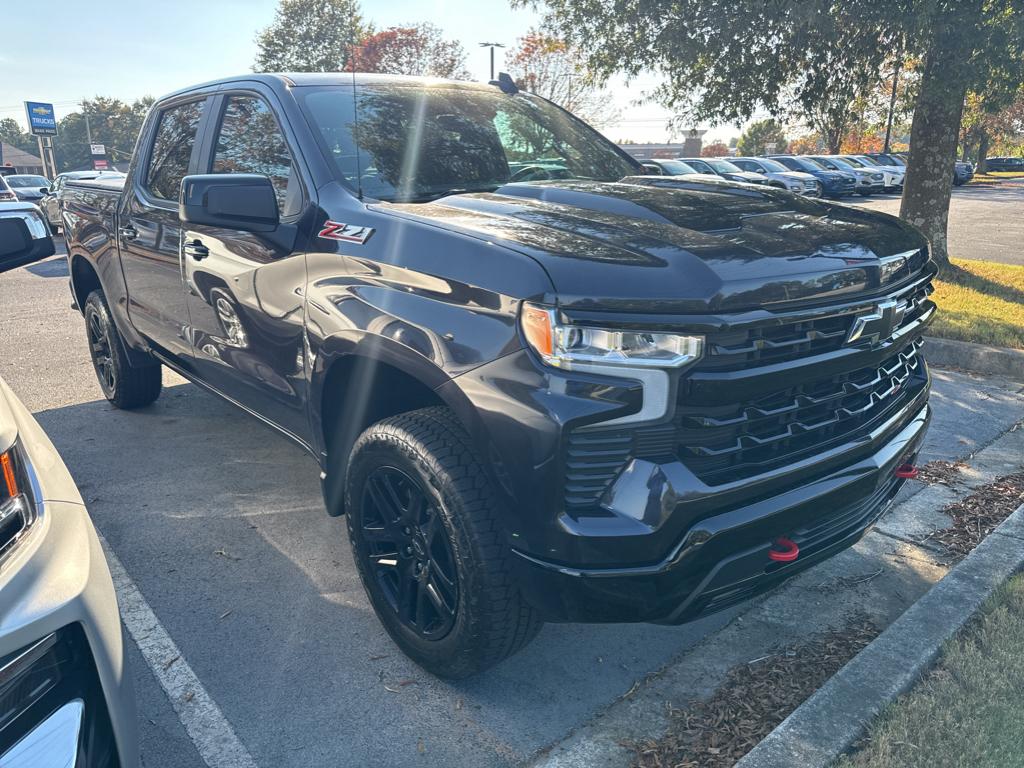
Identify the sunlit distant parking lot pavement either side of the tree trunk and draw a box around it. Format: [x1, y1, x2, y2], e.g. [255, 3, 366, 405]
[844, 181, 1024, 265]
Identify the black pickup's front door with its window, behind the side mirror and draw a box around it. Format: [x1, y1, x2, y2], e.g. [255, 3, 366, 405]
[182, 93, 310, 442]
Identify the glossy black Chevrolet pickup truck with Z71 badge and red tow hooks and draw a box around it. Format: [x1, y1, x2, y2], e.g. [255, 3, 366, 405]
[61, 74, 935, 677]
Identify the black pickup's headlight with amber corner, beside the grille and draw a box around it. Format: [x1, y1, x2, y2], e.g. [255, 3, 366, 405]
[519, 303, 703, 370]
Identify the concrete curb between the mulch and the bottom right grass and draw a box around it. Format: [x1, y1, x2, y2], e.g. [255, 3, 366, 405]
[736, 506, 1024, 768]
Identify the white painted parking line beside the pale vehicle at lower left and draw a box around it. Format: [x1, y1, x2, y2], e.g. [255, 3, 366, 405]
[99, 537, 256, 768]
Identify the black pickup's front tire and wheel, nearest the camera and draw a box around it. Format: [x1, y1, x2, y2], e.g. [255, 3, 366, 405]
[345, 408, 542, 679]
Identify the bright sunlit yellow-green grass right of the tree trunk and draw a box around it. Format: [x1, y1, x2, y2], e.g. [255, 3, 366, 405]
[929, 259, 1024, 352]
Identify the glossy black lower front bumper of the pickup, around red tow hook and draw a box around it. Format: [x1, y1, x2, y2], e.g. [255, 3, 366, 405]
[516, 406, 931, 624]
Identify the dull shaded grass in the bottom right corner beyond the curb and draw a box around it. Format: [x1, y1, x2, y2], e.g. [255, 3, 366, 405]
[836, 577, 1024, 768]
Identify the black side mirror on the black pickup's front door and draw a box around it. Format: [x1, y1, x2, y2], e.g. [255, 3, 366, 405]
[178, 173, 279, 232]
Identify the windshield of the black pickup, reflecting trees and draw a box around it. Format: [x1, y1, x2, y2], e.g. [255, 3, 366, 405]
[295, 84, 642, 202]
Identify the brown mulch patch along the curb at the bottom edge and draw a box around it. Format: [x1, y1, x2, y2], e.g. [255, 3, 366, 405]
[624, 615, 881, 768]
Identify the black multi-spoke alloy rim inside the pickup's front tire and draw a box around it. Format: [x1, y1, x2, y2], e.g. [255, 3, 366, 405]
[360, 466, 459, 640]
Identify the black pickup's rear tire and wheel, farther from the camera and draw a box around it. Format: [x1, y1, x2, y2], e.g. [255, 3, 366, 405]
[82, 290, 162, 411]
